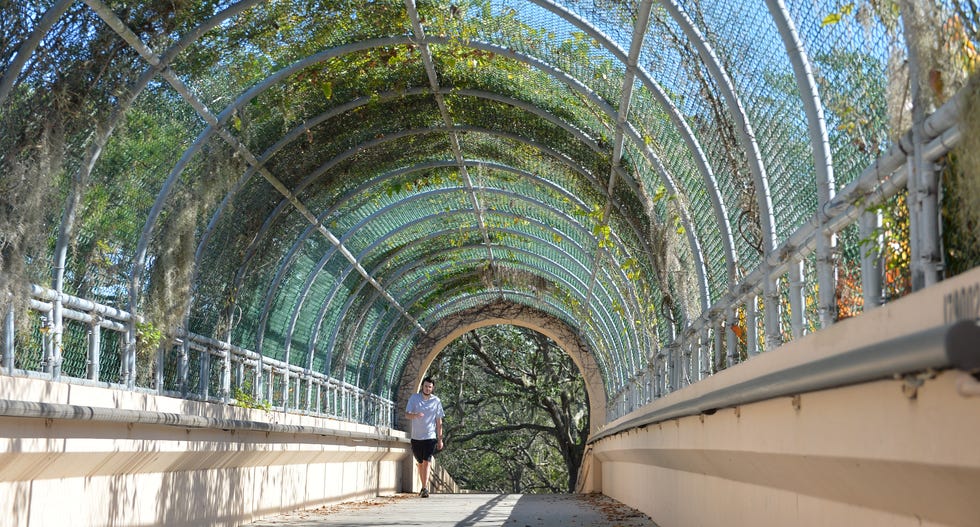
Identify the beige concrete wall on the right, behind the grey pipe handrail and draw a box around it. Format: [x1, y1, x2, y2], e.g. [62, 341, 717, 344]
[583, 272, 980, 527]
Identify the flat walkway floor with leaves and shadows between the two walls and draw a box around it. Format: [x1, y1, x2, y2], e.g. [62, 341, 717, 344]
[248, 494, 656, 527]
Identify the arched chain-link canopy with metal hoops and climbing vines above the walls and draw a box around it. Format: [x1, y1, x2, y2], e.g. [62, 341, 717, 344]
[0, 0, 980, 527]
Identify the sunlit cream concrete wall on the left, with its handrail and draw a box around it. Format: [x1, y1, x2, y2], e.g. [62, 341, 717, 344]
[0, 376, 412, 527]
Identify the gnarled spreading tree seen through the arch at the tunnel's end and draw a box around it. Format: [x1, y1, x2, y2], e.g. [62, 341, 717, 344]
[435, 326, 589, 493]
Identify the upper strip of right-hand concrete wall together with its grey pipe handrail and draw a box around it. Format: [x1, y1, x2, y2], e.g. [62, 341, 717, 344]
[590, 268, 980, 441]
